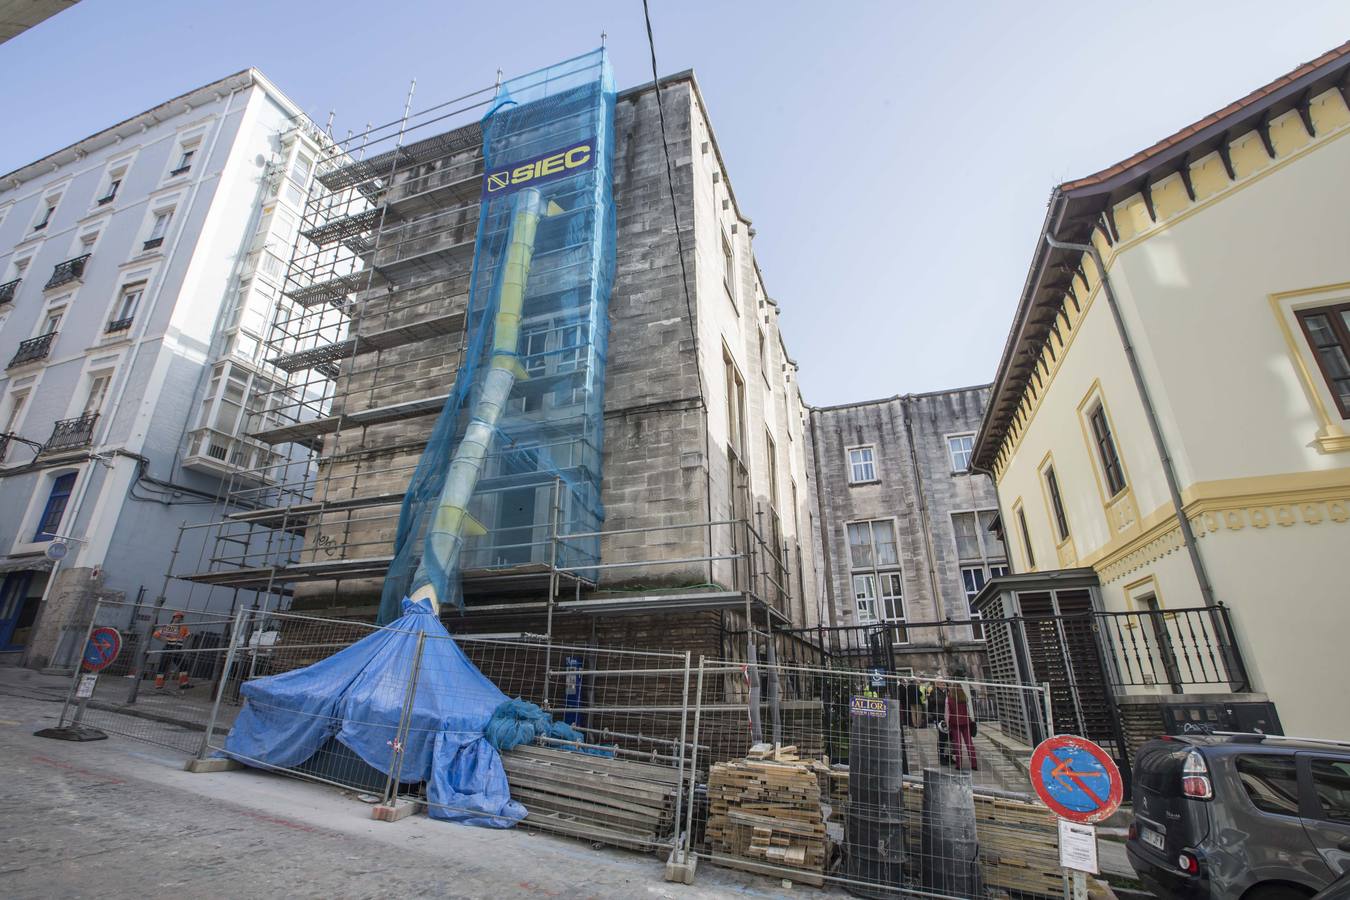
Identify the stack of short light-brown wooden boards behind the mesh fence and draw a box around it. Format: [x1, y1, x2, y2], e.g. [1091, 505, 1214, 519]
[706, 743, 829, 885]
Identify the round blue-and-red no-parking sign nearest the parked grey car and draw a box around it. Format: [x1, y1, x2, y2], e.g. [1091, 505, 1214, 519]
[1031, 734, 1125, 824]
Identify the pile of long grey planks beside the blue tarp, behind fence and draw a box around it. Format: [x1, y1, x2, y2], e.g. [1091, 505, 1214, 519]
[502, 745, 679, 851]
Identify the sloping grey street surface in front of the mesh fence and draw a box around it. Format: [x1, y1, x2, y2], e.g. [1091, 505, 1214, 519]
[0, 669, 799, 899]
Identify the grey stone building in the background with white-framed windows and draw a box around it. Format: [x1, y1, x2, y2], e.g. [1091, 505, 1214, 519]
[810, 386, 1008, 672]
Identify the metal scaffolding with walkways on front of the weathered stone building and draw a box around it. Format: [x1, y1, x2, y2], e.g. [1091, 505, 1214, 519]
[166, 52, 799, 647]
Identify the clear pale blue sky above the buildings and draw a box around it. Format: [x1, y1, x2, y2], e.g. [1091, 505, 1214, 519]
[0, 0, 1350, 405]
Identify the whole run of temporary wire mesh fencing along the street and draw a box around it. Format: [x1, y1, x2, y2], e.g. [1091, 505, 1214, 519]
[49, 603, 1096, 897]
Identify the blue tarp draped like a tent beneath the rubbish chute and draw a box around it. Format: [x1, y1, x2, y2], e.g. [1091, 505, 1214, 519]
[224, 600, 525, 827]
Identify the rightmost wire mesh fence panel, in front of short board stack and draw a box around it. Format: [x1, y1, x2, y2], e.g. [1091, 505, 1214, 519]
[680, 660, 1062, 897]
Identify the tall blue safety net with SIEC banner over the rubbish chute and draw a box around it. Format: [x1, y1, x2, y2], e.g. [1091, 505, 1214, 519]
[379, 50, 614, 623]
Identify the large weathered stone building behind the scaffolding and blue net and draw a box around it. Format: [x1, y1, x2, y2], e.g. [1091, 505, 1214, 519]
[176, 63, 819, 653]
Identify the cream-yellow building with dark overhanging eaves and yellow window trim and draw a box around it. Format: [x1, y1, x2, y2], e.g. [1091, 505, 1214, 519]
[975, 43, 1350, 743]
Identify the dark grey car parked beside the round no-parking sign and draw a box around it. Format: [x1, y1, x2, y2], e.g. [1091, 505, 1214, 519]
[1126, 734, 1350, 900]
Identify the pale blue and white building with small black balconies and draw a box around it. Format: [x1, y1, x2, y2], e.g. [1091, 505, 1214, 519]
[0, 69, 324, 667]
